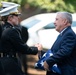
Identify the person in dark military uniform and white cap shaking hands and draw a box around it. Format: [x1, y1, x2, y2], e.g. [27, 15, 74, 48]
[0, 2, 38, 75]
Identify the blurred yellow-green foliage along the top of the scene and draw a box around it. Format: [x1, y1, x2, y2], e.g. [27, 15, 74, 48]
[1, 0, 76, 13]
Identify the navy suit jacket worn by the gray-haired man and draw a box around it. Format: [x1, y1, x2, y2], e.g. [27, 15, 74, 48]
[46, 26, 76, 75]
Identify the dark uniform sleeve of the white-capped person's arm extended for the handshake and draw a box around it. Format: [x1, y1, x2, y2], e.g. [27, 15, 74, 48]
[9, 29, 38, 54]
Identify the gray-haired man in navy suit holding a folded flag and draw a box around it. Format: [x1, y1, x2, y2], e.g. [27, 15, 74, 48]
[36, 12, 76, 75]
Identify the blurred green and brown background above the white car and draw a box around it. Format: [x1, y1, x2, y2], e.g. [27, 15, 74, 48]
[0, 0, 76, 19]
